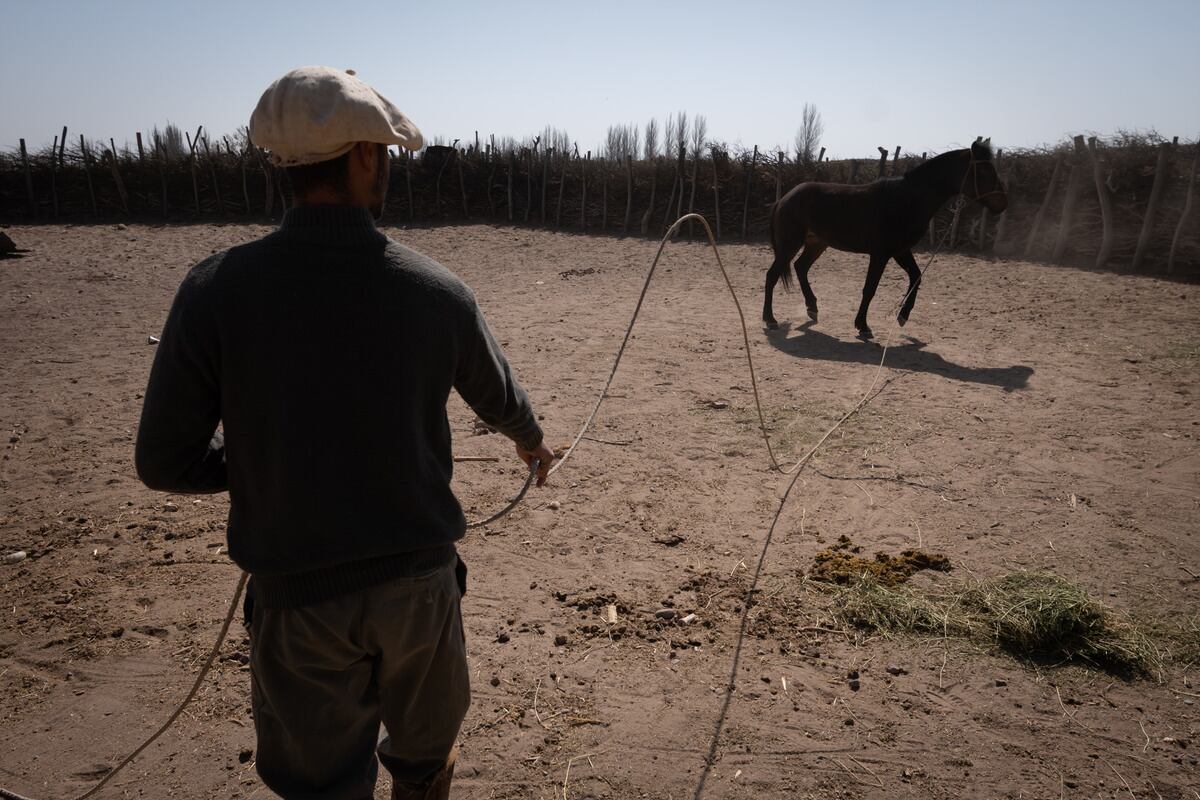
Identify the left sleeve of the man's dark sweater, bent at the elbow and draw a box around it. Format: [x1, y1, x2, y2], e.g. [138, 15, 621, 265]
[134, 261, 228, 494]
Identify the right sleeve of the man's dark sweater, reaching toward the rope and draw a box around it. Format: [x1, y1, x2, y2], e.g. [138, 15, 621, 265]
[455, 297, 542, 450]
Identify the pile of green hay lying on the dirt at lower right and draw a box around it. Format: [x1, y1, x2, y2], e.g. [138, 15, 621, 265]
[834, 572, 1163, 674]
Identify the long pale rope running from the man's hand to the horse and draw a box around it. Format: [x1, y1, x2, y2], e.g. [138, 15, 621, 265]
[0, 201, 966, 800]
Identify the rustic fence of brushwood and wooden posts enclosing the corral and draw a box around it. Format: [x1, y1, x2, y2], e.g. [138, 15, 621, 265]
[0, 126, 1200, 273]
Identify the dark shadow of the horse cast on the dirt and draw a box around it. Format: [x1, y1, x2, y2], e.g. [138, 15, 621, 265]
[766, 321, 1033, 391]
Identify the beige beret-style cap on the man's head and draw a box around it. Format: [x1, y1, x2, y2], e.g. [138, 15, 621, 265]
[250, 67, 422, 167]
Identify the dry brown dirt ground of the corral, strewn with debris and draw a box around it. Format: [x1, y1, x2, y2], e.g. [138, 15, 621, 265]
[0, 220, 1200, 800]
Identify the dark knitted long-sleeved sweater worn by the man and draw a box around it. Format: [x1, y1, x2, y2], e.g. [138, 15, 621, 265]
[137, 206, 541, 607]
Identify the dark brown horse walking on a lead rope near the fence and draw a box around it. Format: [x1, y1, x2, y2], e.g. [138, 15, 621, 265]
[762, 139, 1008, 338]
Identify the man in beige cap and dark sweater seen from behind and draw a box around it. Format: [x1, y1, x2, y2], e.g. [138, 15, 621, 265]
[137, 67, 554, 800]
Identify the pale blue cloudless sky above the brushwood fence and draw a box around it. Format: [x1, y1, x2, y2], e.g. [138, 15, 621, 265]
[0, 0, 1200, 157]
